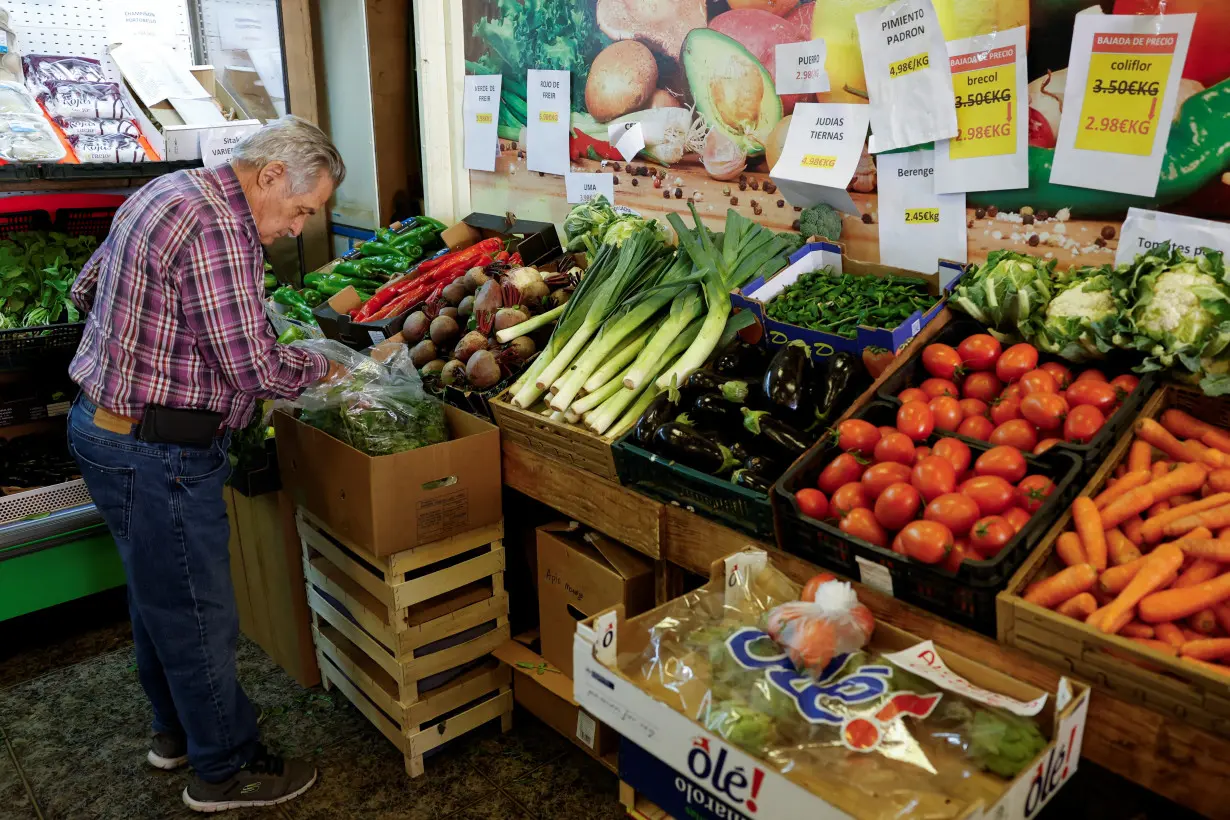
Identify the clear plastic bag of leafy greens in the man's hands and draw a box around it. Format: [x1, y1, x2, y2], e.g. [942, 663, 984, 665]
[281, 339, 449, 456]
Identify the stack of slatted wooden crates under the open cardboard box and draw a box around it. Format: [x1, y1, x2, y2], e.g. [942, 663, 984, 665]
[296, 508, 513, 777]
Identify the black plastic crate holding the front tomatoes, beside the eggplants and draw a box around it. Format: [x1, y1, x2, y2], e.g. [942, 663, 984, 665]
[774, 401, 1080, 636]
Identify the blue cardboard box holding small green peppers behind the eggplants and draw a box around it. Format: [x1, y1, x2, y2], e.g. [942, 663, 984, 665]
[734, 242, 966, 359]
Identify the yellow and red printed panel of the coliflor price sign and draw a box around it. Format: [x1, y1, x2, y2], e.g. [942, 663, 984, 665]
[1075, 33, 1178, 156]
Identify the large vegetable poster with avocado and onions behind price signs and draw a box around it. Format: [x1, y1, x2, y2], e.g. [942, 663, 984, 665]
[464, 0, 1230, 267]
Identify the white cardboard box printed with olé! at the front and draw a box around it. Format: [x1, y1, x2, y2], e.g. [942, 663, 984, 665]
[573, 551, 1090, 820]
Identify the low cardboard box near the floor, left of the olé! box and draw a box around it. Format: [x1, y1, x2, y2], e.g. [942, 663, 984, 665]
[492, 633, 619, 763]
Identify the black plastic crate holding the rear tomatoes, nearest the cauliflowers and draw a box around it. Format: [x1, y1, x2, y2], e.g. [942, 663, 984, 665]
[878, 318, 1156, 476]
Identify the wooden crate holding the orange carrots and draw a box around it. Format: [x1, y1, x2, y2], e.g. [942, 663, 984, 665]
[996, 386, 1230, 736]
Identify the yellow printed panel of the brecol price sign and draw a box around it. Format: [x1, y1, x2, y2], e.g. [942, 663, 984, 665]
[948, 45, 1020, 160]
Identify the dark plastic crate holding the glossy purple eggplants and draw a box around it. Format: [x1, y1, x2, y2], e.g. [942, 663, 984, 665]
[611, 430, 774, 541]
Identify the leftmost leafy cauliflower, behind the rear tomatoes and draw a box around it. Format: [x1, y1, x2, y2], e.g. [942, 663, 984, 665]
[950, 251, 1055, 342]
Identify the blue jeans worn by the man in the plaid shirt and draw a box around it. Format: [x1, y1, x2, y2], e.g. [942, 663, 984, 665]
[69, 396, 257, 782]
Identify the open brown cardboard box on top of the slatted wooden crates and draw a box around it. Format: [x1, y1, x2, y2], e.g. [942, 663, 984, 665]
[274, 407, 503, 556]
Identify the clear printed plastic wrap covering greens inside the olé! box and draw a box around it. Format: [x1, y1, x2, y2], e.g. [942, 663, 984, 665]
[619, 567, 1047, 820]
